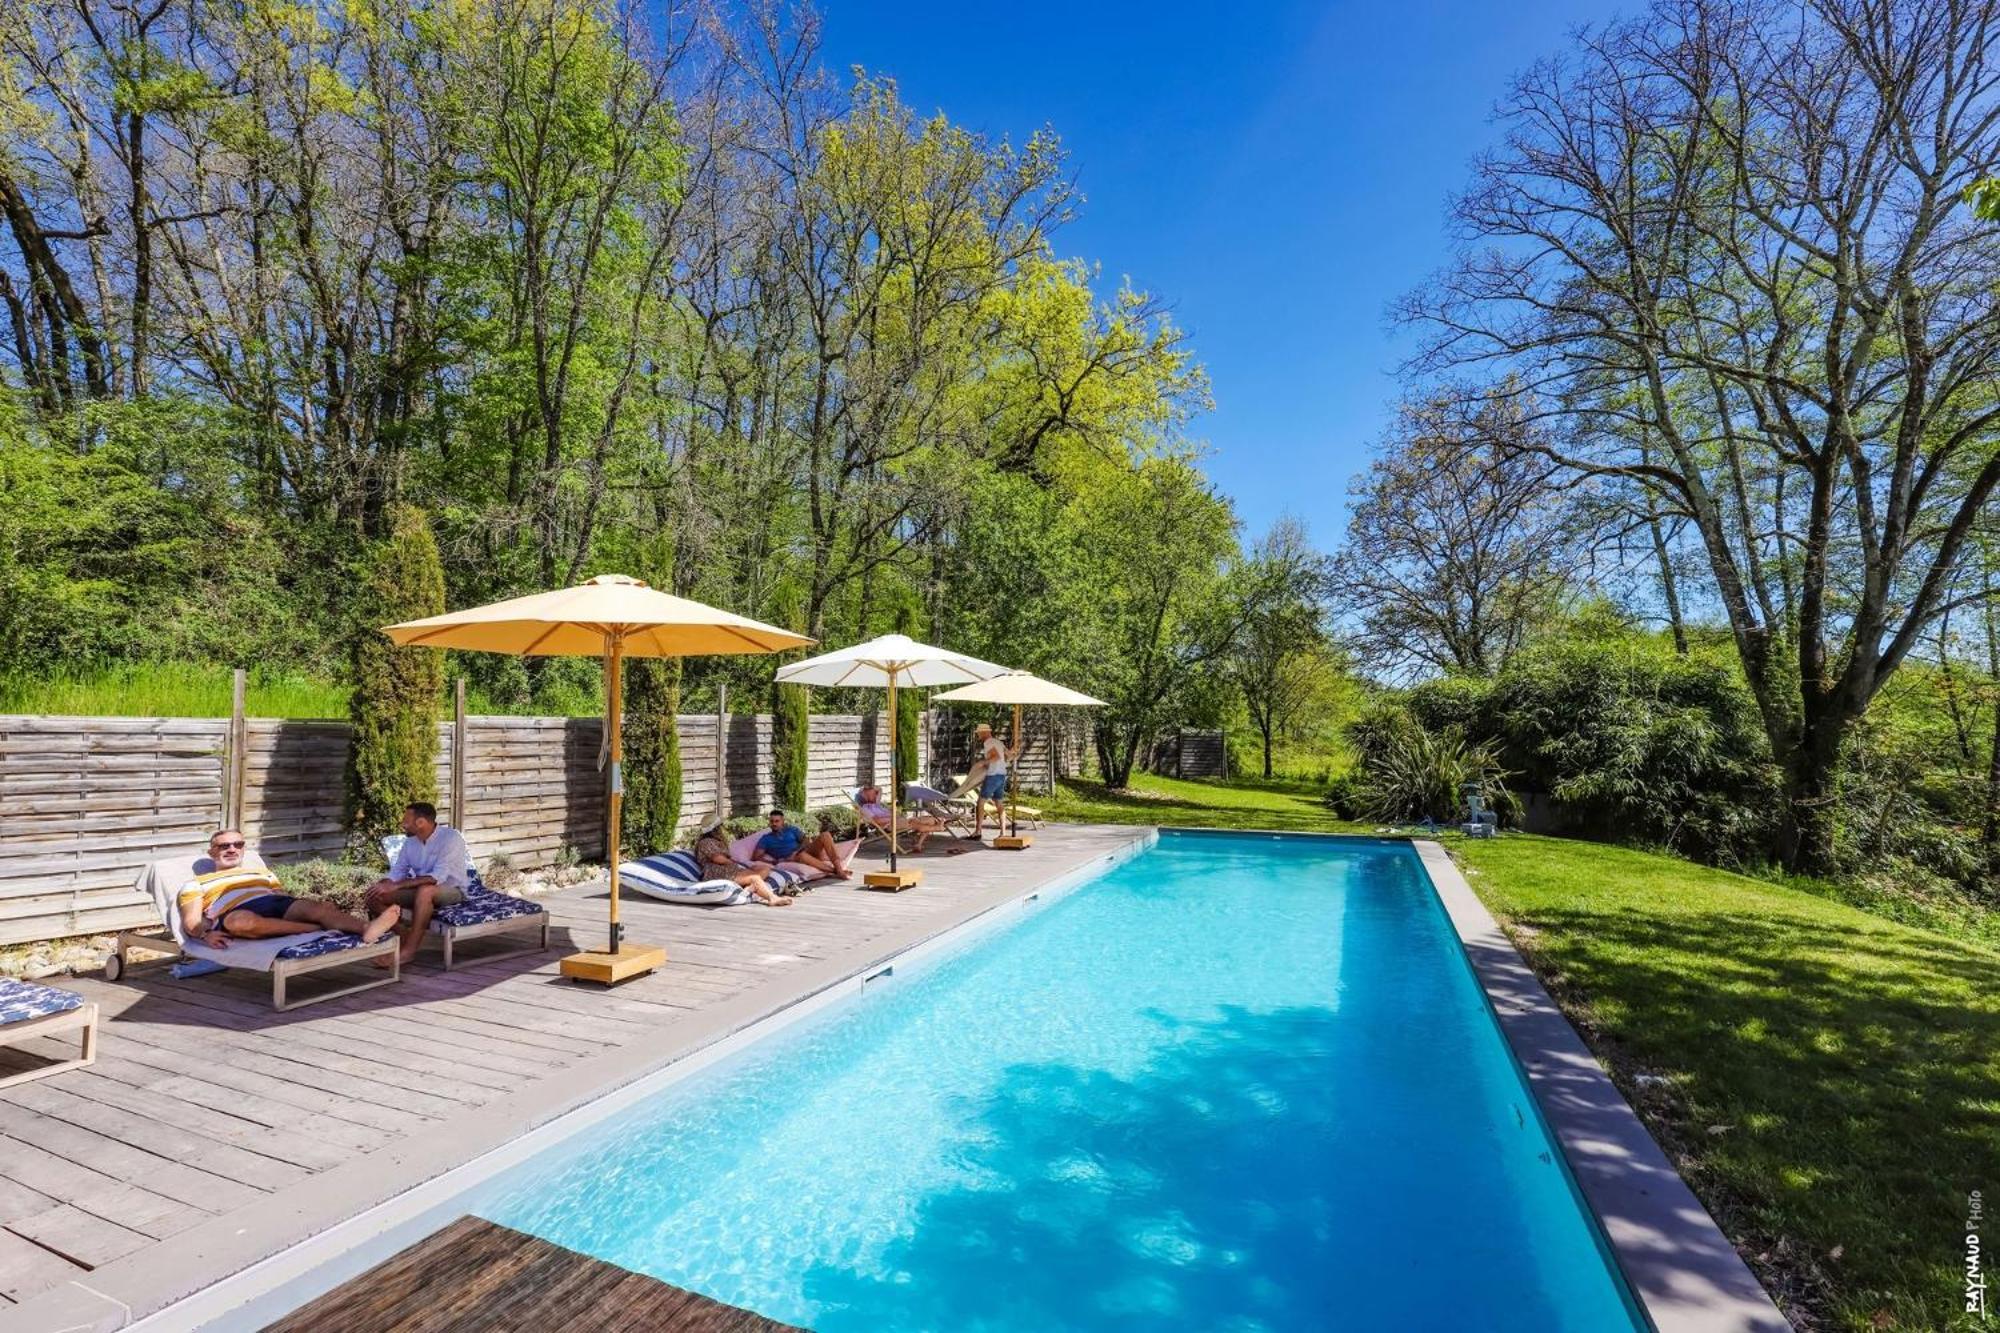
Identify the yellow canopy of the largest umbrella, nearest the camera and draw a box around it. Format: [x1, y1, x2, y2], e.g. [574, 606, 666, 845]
[382, 574, 812, 656]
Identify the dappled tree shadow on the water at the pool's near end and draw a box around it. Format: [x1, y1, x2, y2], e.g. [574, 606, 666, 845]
[788, 1009, 1616, 1333]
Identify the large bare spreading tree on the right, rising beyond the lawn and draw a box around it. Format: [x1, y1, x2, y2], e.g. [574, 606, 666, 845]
[1408, 0, 2000, 873]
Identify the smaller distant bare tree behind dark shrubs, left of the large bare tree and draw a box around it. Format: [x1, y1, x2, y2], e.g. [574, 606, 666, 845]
[1334, 390, 1582, 677]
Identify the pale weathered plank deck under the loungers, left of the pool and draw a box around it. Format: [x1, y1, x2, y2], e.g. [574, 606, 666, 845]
[0, 827, 1148, 1333]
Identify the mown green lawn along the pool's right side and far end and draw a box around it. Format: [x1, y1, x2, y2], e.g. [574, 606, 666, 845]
[1052, 777, 2000, 1333]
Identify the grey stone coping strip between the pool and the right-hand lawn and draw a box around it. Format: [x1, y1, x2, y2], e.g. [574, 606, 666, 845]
[1410, 839, 1792, 1333]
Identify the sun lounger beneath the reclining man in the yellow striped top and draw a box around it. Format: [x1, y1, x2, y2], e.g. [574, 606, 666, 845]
[104, 857, 402, 1009]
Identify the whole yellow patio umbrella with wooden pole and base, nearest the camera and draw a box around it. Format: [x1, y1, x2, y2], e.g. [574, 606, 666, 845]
[382, 574, 812, 983]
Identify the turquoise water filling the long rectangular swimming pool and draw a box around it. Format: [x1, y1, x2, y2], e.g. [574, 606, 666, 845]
[480, 835, 1640, 1333]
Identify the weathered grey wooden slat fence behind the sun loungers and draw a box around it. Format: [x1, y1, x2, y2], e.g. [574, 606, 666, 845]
[0, 715, 928, 945]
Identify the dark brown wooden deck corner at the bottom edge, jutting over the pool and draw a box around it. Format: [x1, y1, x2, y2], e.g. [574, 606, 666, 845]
[264, 1217, 798, 1333]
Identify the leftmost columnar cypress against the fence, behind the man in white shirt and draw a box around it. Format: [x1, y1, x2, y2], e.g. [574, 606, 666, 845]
[346, 504, 456, 851]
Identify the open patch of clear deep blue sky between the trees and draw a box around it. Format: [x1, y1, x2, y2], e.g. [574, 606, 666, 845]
[822, 0, 1632, 546]
